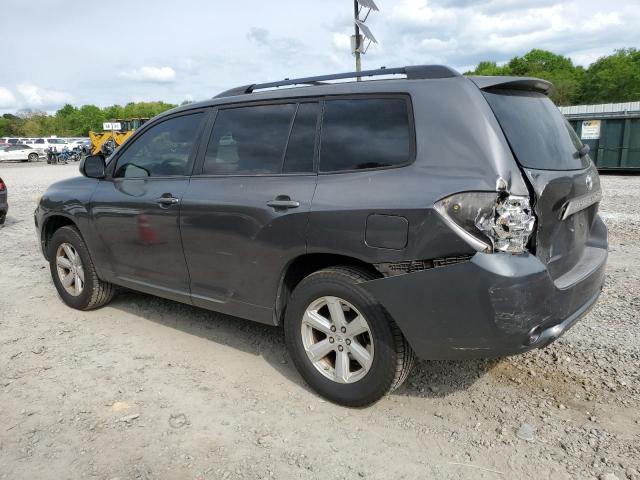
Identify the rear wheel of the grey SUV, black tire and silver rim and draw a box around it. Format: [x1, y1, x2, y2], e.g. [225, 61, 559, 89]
[284, 267, 415, 407]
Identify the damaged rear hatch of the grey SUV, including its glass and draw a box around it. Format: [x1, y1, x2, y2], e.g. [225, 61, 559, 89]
[483, 81, 602, 284]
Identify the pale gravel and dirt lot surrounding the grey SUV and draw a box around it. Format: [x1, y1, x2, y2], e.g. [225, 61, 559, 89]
[0, 164, 640, 480]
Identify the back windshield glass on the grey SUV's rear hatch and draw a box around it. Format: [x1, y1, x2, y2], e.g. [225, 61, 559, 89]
[483, 90, 589, 170]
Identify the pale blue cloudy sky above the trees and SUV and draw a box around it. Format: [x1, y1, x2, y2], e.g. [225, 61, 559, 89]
[0, 0, 640, 112]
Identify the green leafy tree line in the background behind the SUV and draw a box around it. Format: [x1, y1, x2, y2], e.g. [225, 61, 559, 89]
[0, 48, 640, 137]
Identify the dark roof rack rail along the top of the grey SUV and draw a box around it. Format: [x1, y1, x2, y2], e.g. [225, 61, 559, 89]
[213, 65, 460, 98]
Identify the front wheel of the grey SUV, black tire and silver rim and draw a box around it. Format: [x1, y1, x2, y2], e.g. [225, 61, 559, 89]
[47, 226, 115, 310]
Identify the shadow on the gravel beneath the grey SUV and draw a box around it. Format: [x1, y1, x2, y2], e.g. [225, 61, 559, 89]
[109, 290, 500, 398]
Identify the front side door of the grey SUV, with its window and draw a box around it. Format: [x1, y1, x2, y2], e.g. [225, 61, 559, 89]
[91, 111, 205, 301]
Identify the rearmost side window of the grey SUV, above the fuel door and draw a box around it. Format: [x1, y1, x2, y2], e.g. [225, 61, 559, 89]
[320, 98, 411, 172]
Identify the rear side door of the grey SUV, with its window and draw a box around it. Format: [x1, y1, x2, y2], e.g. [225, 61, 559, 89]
[181, 101, 320, 323]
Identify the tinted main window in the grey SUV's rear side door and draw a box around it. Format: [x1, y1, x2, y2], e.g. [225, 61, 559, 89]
[202, 103, 296, 175]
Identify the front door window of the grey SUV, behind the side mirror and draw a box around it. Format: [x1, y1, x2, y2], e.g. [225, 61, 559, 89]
[113, 113, 202, 178]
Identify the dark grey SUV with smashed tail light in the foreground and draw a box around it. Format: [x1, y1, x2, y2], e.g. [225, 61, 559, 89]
[35, 66, 607, 406]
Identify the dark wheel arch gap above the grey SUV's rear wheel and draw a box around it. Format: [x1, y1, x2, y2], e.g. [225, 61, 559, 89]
[274, 253, 382, 325]
